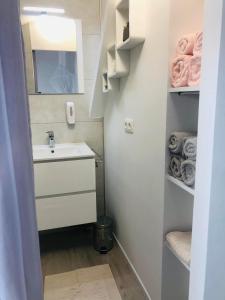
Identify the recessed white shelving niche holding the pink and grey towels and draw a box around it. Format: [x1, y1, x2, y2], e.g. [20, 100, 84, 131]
[162, 0, 204, 300]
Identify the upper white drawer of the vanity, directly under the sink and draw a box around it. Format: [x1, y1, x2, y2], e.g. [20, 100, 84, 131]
[34, 159, 96, 197]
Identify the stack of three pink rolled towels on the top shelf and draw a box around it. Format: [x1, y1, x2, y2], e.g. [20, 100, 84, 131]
[171, 32, 203, 87]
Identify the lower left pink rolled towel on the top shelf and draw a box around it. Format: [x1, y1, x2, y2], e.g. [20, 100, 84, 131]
[171, 55, 192, 87]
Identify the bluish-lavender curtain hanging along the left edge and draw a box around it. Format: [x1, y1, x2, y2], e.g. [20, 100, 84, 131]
[0, 0, 43, 300]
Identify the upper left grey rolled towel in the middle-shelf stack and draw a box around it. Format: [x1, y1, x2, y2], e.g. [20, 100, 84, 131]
[168, 131, 194, 154]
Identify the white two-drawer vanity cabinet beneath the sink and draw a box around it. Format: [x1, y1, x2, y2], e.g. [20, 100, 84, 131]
[34, 143, 97, 231]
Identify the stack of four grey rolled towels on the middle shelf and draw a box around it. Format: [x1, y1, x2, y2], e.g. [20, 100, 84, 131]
[168, 131, 197, 187]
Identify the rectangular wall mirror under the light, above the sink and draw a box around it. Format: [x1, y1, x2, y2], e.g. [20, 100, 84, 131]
[21, 15, 84, 95]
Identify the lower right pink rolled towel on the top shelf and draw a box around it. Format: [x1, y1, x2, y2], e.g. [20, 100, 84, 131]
[188, 55, 201, 86]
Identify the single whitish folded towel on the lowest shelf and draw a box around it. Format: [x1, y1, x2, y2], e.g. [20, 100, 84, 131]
[166, 231, 192, 266]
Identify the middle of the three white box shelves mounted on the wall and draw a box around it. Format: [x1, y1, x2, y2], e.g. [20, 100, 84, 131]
[107, 44, 130, 79]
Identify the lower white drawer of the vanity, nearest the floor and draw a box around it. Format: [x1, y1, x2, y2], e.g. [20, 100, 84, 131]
[36, 192, 97, 231]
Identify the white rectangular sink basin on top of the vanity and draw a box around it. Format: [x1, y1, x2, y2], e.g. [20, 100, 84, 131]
[33, 143, 95, 162]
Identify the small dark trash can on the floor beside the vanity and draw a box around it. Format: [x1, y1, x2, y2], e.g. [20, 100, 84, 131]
[94, 216, 113, 254]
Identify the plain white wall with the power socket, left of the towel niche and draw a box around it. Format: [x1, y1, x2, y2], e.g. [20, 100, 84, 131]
[104, 0, 168, 300]
